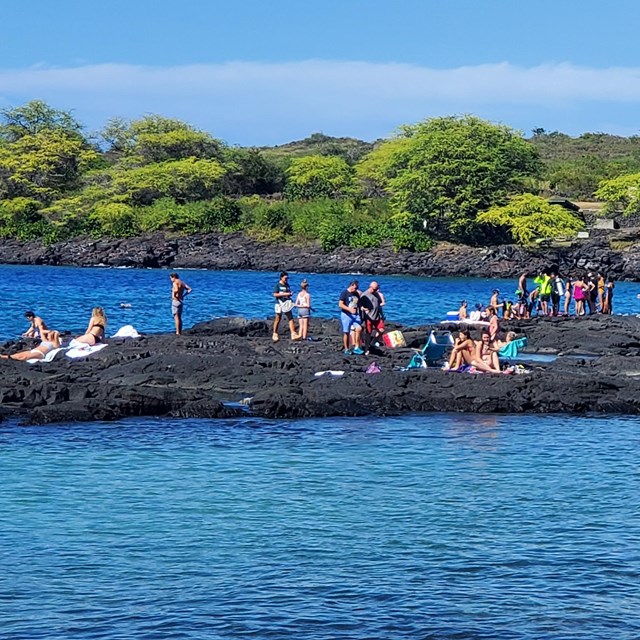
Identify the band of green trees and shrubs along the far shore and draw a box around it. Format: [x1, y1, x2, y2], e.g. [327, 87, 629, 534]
[0, 101, 640, 251]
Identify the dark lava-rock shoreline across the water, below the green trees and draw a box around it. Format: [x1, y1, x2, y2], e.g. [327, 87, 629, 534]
[0, 230, 640, 280]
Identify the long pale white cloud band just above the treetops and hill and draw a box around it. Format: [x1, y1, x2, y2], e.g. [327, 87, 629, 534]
[0, 60, 640, 144]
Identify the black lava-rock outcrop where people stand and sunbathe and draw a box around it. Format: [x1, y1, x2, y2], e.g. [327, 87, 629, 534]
[0, 316, 640, 424]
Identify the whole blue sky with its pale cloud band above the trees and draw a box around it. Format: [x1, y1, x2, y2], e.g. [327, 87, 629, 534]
[0, 0, 640, 146]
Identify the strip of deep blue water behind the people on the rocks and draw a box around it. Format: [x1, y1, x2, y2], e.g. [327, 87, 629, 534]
[0, 265, 640, 340]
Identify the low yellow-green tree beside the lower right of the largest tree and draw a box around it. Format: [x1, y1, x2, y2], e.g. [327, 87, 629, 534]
[478, 193, 584, 245]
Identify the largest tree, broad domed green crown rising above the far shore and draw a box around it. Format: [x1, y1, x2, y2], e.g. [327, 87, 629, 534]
[360, 116, 540, 240]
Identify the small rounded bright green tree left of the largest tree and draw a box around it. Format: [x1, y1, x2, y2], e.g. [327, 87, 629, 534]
[285, 156, 356, 200]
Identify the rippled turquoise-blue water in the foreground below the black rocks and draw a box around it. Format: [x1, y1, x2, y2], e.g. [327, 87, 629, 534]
[0, 415, 640, 640]
